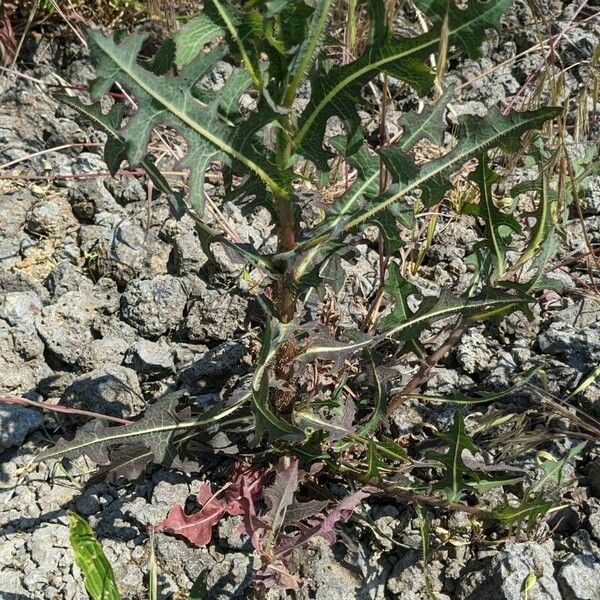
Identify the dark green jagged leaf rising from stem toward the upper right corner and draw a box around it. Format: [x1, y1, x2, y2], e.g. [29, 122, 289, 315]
[293, 0, 511, 171]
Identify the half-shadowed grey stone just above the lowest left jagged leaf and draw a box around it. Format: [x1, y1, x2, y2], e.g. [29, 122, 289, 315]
[62, 365, 146, 418]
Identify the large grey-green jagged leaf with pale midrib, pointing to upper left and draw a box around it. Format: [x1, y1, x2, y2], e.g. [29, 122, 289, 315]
[88, 31, 288, 215]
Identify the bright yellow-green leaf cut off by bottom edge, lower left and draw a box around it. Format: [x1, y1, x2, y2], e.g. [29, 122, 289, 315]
[69, 512, 121, 600]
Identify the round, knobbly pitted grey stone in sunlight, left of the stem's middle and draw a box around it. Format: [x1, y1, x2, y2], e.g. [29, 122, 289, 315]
[121, 275, 188, 338]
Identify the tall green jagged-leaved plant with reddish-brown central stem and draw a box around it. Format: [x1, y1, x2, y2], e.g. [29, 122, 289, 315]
[39, 0, 561, 502]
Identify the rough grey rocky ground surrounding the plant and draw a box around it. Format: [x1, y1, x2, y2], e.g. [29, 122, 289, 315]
[0, 0, 600, 600]
